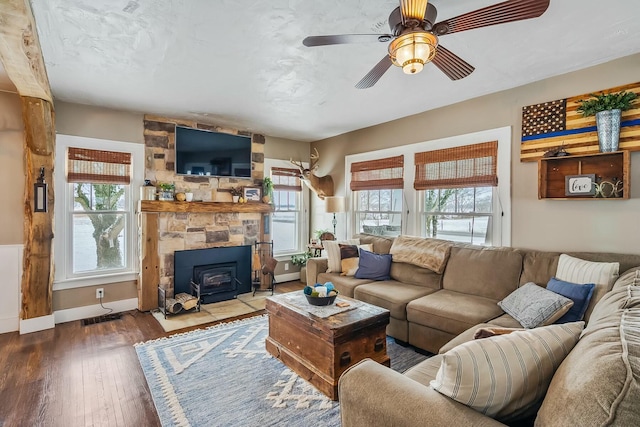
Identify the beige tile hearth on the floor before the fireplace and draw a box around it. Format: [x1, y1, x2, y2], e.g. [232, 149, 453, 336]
[151, 292, 271, 332]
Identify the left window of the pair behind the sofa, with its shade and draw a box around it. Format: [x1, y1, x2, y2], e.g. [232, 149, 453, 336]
[349, 156, 404, 236]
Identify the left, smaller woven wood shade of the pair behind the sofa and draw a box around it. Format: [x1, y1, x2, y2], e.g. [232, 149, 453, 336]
[349, 156, 404, 191]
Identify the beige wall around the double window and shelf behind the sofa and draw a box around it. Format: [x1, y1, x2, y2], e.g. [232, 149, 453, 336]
[311, 54, 640, 254]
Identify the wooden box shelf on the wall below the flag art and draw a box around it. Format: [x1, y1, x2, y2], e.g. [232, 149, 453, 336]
[538, 150, 631, 200]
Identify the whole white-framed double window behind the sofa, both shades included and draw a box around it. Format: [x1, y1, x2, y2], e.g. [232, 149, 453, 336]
[345, 127, 511, 246]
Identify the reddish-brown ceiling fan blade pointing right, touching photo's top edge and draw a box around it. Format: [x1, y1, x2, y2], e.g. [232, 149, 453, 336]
[433, 0, 550, 36]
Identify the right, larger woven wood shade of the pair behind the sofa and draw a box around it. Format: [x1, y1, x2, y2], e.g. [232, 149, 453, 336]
[413, 141, 498, 190]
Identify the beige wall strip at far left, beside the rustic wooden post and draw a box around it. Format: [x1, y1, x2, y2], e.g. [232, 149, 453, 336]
[0, 92, 25, 245]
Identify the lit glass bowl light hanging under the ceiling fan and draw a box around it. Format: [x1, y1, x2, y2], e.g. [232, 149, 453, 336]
[389, 31, 438, 74]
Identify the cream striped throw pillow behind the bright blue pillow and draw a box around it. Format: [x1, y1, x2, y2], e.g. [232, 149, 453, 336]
[555, 254, 620, 319]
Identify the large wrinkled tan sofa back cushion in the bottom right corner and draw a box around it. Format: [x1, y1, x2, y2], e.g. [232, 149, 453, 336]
[536, 286, 640, 426]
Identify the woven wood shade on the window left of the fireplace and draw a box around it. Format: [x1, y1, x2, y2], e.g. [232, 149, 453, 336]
[67, 147, 131, 184]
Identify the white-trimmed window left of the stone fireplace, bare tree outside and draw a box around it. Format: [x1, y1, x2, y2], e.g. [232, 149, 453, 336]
[54, 135, 144, 289]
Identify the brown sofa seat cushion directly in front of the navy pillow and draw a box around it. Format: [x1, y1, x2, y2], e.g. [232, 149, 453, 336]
[354, 280, 435, 320]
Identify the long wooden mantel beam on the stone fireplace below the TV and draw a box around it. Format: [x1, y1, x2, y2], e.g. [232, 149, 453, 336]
[138, 200, 273, 213]
